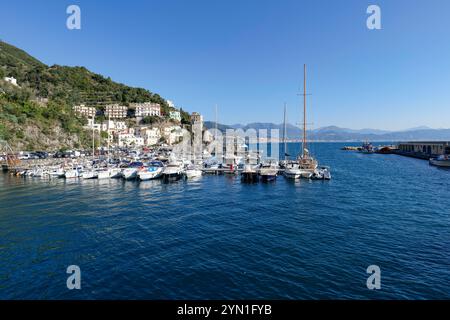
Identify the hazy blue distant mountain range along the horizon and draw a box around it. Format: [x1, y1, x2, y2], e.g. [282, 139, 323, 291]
[205, 121, 450, 141]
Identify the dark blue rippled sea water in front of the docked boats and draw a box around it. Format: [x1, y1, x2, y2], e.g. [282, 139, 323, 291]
[0, 143, 450, 299]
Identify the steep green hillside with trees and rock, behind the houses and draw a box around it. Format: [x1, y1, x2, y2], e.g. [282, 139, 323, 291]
[0, 41, 189, 150]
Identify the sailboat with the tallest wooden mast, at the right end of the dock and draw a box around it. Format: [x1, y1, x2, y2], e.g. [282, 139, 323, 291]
[284, 64, 331, 179]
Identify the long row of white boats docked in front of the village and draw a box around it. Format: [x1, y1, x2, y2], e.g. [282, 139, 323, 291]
[11, 158, 331, 182]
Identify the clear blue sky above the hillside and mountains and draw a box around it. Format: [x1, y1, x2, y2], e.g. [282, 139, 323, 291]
[0, 0, 450, 130]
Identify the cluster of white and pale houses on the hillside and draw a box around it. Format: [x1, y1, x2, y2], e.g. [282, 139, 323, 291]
[73, 101, 203, 147]
